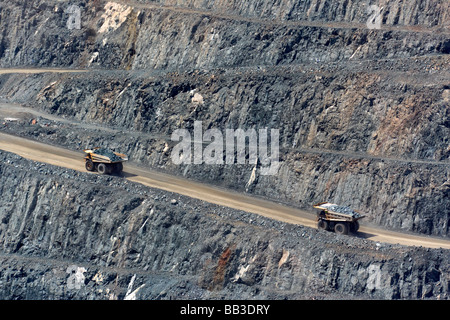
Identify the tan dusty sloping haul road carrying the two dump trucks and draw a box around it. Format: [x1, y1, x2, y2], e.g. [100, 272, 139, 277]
[0, 133, 450, 249]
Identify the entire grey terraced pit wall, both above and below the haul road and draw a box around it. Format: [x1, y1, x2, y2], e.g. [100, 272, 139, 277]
[0, 0, 450, 299]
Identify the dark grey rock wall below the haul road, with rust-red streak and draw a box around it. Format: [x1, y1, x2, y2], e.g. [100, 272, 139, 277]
[0, 152, 450, 299]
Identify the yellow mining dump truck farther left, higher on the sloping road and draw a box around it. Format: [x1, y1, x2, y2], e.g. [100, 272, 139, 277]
[84, 148, 128, 174]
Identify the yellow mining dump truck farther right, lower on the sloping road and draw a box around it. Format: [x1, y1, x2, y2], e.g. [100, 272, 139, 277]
[313, 202, 364, 234]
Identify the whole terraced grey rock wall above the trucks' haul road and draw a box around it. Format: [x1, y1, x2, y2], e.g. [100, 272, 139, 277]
[0, 1, 450, 236]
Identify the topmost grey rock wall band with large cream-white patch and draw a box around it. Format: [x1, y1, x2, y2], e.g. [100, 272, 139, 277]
[0, 0, 450, 70]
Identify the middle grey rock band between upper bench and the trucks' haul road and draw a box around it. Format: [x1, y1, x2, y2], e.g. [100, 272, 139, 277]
[0, 57, 450, 236]
